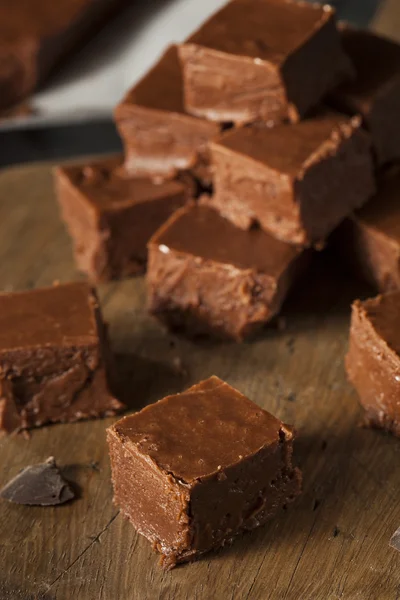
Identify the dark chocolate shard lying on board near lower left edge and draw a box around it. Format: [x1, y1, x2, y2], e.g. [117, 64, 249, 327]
[0, 456, 75, 506]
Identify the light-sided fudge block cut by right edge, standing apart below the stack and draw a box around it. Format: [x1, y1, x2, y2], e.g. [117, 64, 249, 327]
[346, 291, 400, 436]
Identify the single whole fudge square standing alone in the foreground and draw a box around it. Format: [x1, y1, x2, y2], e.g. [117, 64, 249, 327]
[107, 376, 301, 568]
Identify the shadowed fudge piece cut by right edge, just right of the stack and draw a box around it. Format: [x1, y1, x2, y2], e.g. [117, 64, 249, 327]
[333, 171, 400, 292]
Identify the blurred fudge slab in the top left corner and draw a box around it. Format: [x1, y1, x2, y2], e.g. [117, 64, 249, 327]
[0, 0, 128, 109]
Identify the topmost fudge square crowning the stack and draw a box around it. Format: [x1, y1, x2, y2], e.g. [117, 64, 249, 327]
[179, 0, 353, 124]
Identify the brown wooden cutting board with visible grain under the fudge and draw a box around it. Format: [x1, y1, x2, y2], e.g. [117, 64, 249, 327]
[0, 161, 400, 600]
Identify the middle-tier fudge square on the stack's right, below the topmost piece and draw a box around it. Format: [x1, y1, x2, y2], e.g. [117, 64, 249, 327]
[210, 114, 375, 246]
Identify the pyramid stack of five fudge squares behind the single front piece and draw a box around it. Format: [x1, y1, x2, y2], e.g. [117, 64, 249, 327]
[57, 0, 384, 340]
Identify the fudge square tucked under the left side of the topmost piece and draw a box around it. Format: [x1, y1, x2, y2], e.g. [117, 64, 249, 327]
[115, 46, 220, 183]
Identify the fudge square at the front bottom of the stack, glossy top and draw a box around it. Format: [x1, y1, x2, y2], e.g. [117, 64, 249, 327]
[147, 205, 308, 341]
